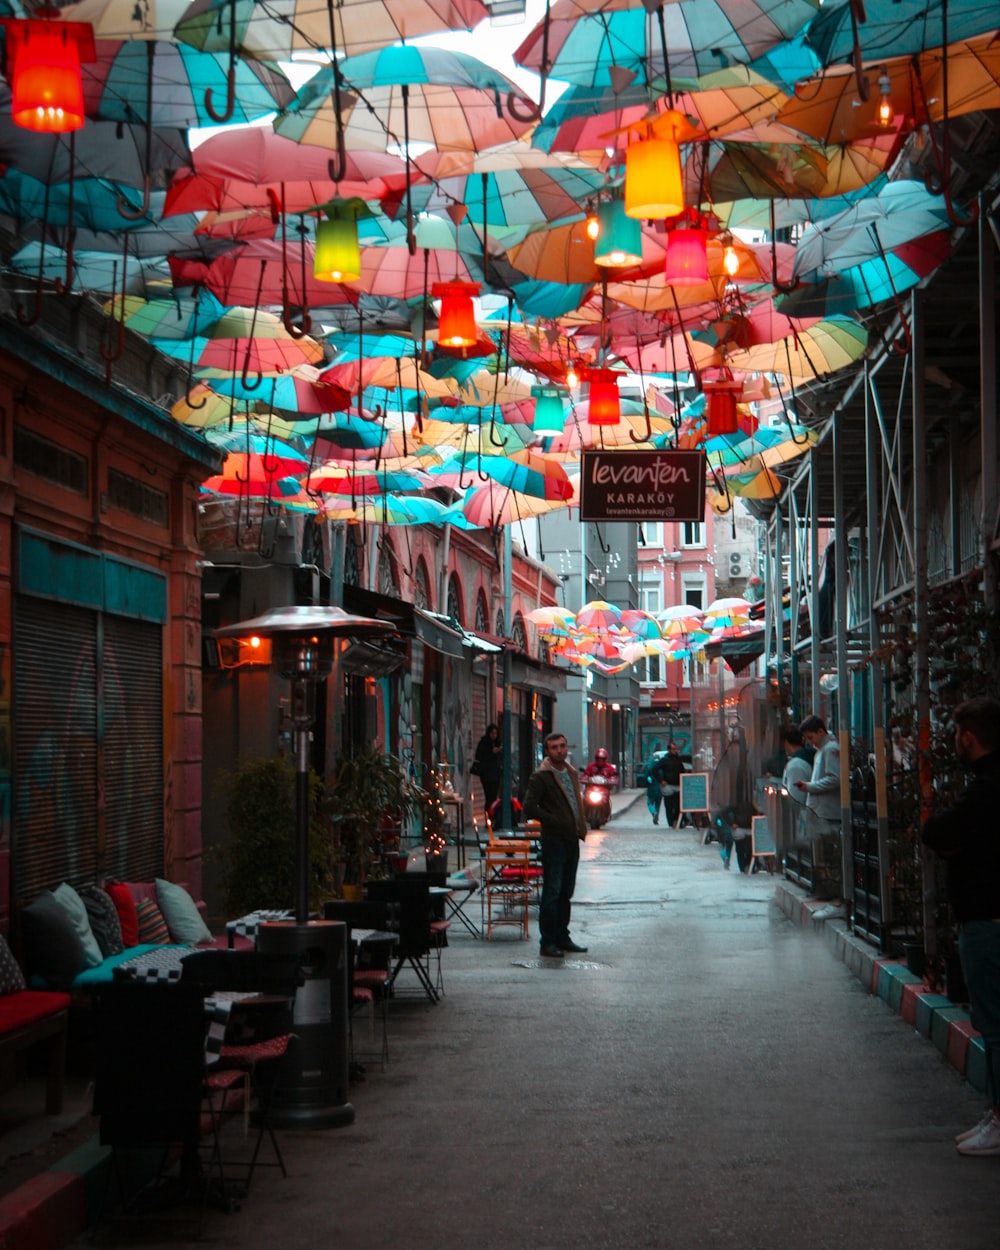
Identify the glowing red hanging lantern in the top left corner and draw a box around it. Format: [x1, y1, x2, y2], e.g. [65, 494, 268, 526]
[3, 16, 98, 134]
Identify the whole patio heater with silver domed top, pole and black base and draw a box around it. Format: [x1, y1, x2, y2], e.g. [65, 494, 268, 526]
[215, 606, 394, 1129]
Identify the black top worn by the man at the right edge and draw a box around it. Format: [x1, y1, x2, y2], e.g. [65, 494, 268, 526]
[920, 751, 1000, 924]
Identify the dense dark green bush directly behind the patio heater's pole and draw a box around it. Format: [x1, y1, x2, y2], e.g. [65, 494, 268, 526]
[211, 759, 334, 916]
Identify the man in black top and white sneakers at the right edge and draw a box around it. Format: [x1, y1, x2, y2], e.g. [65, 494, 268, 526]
[921, 696, 1000, 1155]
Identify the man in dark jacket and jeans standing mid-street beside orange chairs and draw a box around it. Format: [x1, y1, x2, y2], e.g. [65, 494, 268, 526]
[524, 734, 586, 959]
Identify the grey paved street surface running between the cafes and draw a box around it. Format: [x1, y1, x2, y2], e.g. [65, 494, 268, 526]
[78, 803, 1000, 1250]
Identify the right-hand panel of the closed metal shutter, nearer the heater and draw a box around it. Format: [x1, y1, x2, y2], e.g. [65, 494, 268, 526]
[101, 615, 164, 881]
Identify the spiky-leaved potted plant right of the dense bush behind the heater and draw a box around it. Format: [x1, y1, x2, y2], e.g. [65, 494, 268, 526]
[323, 746, 419, 893]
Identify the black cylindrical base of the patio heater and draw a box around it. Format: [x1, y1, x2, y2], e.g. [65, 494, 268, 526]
[258, 920, 354, 1129]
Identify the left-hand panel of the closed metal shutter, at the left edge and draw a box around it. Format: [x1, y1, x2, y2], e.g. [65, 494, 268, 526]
[11, 596, 98, 901]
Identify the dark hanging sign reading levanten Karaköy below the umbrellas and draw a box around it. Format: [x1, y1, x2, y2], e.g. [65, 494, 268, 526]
[580, 448, 705, 521]
